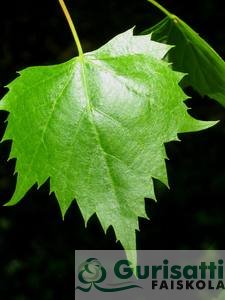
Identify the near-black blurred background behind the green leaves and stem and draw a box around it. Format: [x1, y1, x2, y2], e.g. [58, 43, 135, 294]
[0, 0, 225, 300]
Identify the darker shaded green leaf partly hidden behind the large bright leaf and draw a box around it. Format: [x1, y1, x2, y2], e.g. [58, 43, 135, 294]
[143, 15, 225, 106]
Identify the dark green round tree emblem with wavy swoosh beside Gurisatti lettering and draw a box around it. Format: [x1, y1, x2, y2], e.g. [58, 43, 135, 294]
[75, 258, 141, 293]
